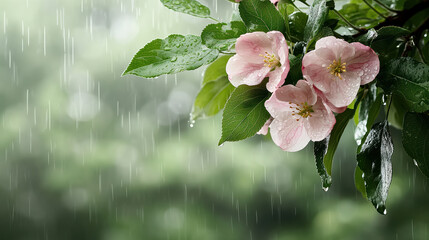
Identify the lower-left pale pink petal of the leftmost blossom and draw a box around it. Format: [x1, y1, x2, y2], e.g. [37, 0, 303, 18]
[226, 55, 270, 87]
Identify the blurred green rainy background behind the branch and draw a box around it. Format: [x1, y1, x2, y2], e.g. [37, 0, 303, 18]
[0, 0, 429, 240]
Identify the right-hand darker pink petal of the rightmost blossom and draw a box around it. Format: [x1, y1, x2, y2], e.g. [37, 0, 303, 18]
[347, 42, 380, 85]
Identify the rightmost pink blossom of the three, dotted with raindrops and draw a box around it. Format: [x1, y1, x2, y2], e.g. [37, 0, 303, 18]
[302, 37, 380, 112]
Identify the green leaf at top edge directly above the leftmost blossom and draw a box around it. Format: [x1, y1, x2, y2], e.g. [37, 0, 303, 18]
[239, 0, 285, 32]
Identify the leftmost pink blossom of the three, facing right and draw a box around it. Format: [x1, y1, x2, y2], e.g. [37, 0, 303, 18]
[226, 31, 289, 92]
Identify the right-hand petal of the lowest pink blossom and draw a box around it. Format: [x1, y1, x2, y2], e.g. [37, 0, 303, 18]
[304, 97, 336, 141]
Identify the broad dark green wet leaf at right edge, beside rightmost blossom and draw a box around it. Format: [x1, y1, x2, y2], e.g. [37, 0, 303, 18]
[377, 58, 429, 112]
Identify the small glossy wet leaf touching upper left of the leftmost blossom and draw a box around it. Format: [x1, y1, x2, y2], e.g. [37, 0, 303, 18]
[201, 21, 247, 51]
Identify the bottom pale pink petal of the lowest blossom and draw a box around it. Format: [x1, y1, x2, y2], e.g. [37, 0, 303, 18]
[270, 116, 310, 152]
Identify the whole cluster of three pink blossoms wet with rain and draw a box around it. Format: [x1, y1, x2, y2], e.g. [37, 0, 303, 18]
[226, 31, 380, 152]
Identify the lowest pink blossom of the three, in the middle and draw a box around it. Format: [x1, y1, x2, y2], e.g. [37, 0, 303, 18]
[265, 80, 336, 152]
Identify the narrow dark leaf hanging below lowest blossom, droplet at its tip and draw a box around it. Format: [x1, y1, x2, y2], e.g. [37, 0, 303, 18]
[314, 137, 332, 191]
